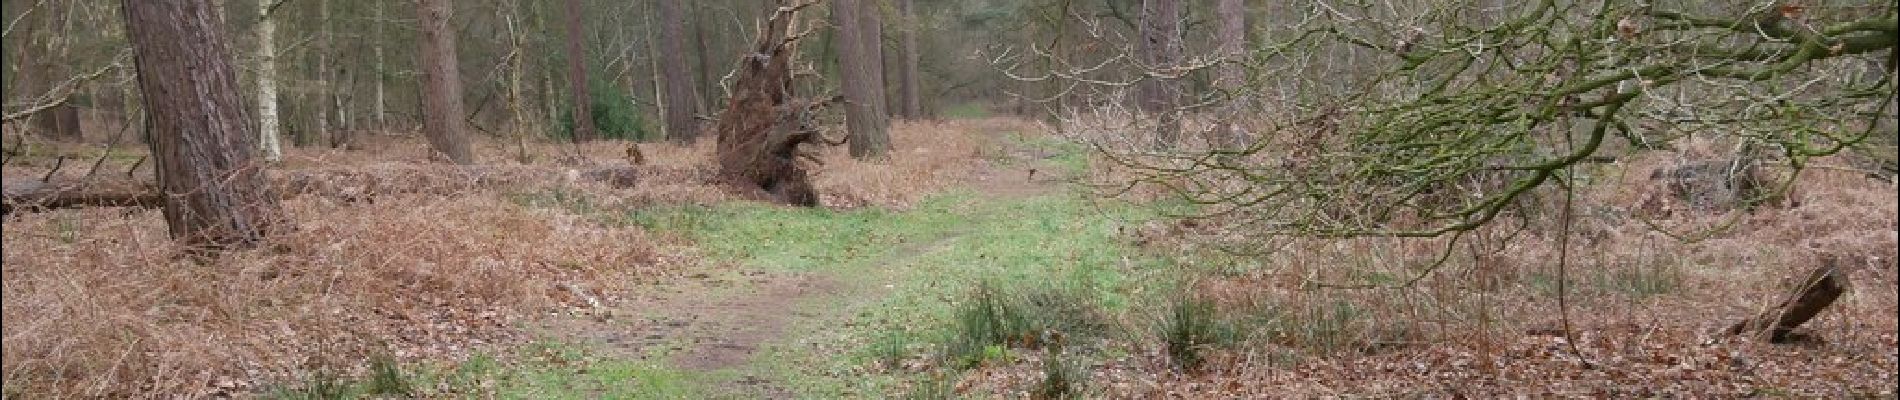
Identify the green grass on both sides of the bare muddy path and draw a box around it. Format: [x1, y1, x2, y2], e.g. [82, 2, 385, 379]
[475, 135, 1170, 398]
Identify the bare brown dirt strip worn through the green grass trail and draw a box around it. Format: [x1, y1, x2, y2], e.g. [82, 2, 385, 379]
[547, 139, 1062, 398]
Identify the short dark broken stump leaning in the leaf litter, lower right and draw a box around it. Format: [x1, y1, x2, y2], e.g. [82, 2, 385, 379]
[1727, 258, 1849, 343]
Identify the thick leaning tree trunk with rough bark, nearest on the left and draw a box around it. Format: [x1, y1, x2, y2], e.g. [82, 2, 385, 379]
[122, 0, 285, 248]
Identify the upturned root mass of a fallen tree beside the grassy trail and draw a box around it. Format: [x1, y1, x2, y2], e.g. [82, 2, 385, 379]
[714, 0, 840, 207]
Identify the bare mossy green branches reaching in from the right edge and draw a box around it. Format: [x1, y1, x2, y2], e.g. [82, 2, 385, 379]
[1018, 0, 1900, 245]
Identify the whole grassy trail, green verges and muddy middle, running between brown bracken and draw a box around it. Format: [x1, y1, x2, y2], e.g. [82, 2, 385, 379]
[446, 132, 1151, 398]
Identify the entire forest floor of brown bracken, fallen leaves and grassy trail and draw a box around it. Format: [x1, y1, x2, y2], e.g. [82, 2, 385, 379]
[0, 114, 1900, 398]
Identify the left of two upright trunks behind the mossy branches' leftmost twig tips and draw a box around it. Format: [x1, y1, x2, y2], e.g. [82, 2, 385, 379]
[1136, 0, 1182, 148]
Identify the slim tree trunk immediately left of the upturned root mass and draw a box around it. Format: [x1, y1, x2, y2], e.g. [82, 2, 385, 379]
[656, 2, 699, 142]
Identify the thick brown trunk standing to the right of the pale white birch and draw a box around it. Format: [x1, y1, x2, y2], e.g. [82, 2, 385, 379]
[416, 0, 475, 165]
